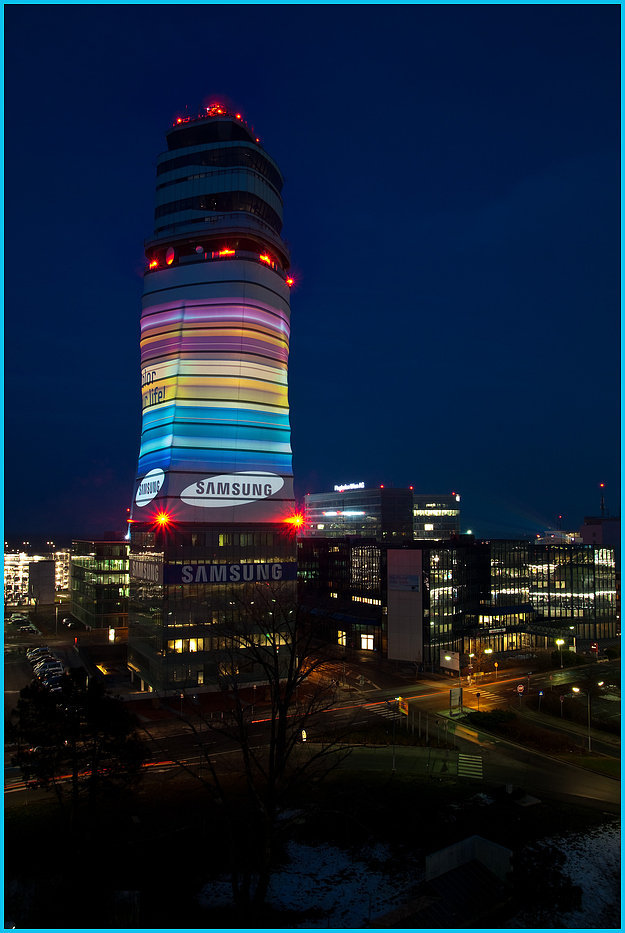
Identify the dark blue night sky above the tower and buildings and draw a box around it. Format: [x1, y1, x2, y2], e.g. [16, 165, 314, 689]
[5, 5, 620, 543]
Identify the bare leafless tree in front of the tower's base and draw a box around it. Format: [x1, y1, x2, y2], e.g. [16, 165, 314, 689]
[144, 583, 349, 909]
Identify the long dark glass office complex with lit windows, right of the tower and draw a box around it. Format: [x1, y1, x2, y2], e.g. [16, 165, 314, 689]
[298, 535, 619, 665]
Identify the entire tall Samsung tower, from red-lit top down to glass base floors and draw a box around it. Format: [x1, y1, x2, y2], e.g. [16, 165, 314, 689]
[129, 104, 297, 689]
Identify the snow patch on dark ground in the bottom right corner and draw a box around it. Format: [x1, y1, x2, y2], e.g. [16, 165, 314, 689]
[510, 823, 621, 930]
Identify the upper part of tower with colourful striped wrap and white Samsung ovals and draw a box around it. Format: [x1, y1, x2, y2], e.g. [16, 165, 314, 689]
[131, 104, 294, 527]
